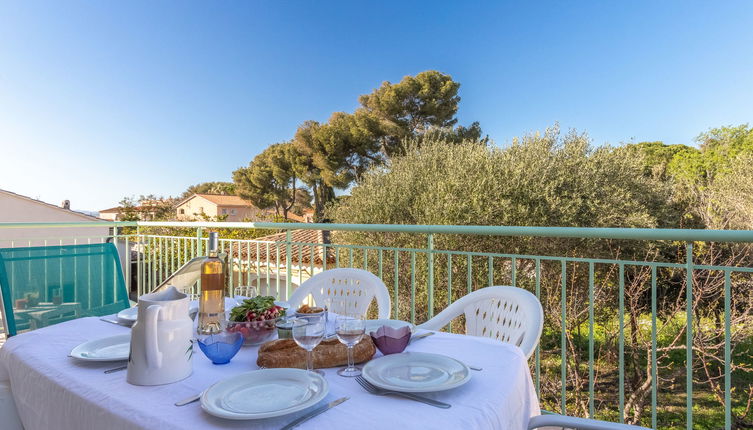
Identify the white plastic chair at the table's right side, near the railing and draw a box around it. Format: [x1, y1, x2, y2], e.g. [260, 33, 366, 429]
[419, 287, 544, 358]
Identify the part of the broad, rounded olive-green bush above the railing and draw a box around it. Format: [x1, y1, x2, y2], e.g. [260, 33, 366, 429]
[333, 128, 670, 233]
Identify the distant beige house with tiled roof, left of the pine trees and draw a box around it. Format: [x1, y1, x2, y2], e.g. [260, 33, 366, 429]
[175, 194, 274, 221]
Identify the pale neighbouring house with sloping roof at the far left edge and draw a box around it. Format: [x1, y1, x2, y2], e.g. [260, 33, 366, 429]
[0, 190, 110, 248]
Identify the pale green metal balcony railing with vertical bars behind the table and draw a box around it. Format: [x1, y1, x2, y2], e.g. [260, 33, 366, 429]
[0, 222, 753, 429]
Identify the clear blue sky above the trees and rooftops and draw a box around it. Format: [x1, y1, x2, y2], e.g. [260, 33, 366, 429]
[0, 0, 753, 210]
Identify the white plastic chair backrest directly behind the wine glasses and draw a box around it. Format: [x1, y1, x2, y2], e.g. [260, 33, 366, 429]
[288, 269, 390, 319]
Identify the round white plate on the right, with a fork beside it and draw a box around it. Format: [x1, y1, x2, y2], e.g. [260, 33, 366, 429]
[361, 352, 471, 393]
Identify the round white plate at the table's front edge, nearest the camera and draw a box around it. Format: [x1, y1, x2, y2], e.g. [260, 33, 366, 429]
[201, 369, 329, 420]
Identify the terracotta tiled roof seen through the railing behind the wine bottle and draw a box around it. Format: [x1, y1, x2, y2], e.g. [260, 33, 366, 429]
[227, 230, 335, 266]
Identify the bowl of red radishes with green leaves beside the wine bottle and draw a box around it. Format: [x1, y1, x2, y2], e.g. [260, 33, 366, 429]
[226, 296, 285, 346]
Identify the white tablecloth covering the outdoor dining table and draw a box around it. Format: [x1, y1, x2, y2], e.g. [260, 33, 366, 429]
[0, 318, 539, 430]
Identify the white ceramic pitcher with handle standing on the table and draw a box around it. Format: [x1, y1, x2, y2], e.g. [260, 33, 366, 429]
[126, 287, 193, 385]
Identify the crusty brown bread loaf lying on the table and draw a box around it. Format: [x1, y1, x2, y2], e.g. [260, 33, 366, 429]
[256, 336, 376, 369]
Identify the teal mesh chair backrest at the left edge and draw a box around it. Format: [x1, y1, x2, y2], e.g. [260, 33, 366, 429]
[0, 243, 129, 336]
